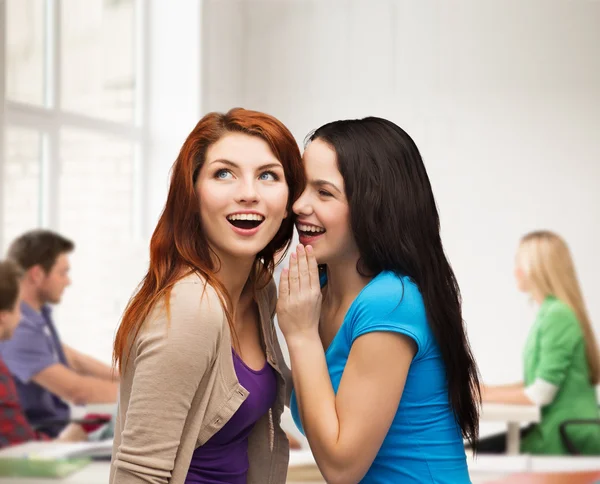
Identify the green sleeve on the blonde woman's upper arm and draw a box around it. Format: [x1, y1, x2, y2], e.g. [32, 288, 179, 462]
[535, 305, 583, 387]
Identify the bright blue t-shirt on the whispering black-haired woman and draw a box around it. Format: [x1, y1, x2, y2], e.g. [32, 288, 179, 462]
[290, 272, 471, 484]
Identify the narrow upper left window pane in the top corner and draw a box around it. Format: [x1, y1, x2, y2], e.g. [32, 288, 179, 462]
[6, 0, 45, 104]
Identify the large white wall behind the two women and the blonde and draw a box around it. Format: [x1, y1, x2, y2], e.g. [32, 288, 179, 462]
[203, 0, 600, 383]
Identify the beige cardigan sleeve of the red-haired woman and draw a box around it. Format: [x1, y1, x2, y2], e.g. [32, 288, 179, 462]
[112, 282, 226, 484]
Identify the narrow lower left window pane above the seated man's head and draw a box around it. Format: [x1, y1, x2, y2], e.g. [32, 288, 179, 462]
[2, 128, 41, 249]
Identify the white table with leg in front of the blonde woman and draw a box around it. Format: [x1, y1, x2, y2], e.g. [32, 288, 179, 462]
[480, 402, 541, 455]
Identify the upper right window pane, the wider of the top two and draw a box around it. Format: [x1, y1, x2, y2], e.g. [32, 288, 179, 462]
[61, 0, 136, 122]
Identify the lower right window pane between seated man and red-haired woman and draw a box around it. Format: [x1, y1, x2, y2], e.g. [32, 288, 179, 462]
[57, 129, 136, 360]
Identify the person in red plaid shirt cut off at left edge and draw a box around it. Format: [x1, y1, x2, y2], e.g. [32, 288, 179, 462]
[0, 261, 86, 449]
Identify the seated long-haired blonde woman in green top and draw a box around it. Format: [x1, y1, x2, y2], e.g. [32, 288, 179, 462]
[478, 231, 600, 455]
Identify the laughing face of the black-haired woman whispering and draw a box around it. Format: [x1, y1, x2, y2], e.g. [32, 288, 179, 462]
[293, 139, 359, 264]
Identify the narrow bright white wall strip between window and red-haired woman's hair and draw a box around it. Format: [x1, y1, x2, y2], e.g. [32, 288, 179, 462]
[146, 0, 203, 234]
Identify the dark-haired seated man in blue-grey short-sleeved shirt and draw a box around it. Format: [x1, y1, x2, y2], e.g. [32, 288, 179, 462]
[0, 230, 118, 437]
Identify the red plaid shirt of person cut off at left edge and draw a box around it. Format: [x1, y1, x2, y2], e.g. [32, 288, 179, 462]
[0, 362, 50, 448]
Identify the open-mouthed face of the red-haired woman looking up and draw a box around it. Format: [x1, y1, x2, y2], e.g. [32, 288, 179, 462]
[195, 133, 289, 259]
